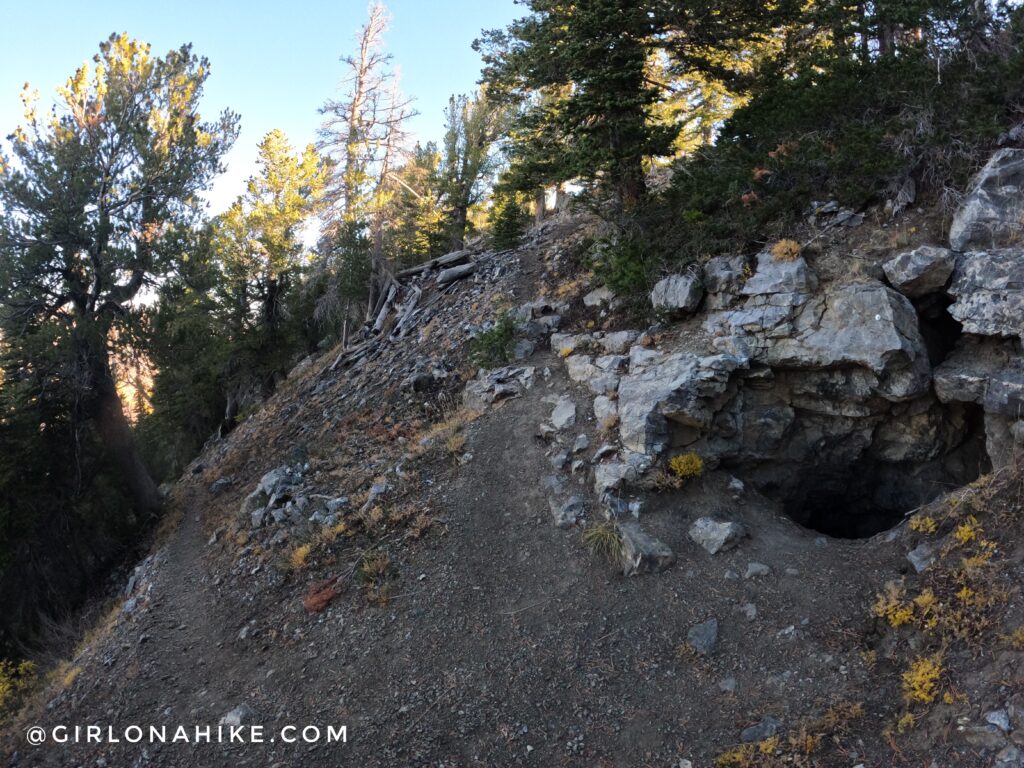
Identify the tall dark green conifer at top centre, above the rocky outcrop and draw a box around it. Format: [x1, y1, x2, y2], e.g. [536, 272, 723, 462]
[474, 0, 676, 210]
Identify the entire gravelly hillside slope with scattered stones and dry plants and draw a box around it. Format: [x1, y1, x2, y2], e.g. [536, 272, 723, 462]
[10, 189, 1024, 768]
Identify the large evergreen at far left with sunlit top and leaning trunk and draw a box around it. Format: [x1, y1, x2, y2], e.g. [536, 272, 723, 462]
[0, 35, 236, 518]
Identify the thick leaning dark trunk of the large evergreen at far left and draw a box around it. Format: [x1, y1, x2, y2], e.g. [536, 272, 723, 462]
[93, 360, 160, 514]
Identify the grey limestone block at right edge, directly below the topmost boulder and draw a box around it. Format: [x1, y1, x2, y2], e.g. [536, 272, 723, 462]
[949, 248, 1024, 338]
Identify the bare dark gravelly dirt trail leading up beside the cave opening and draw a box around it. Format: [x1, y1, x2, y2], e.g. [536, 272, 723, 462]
[19, 356, 913, 768]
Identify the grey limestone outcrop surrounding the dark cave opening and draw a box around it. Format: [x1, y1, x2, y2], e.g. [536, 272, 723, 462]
[551, 147, 1024, 536]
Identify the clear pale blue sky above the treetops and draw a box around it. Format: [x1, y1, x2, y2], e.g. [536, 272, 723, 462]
[0, 0, 522, 211]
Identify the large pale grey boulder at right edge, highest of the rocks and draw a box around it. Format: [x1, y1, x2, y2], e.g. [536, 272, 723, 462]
[949, 148, 1024, 251]
